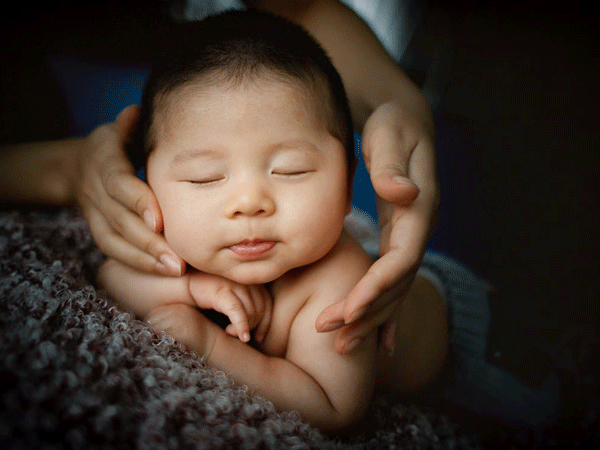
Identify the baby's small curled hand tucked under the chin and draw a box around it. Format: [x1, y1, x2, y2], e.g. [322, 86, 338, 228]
[189, 272, 273, 343]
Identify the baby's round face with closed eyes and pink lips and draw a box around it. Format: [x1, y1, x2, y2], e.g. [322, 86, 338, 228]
[148, 75, 349, 284]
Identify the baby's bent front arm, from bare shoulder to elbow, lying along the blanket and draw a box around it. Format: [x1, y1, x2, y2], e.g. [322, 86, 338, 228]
[176, 236, 377, 431]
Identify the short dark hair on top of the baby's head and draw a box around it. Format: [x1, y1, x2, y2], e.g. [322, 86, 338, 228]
[128, 10, 354, 173]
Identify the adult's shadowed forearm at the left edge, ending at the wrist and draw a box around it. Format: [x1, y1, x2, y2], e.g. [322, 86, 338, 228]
[0, 138, 82, 206]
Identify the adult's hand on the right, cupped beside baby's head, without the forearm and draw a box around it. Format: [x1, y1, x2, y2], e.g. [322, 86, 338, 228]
[316, 102, 439, 353]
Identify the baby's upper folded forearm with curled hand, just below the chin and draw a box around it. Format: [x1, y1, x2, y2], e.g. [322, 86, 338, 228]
[97, 259, 272, 342]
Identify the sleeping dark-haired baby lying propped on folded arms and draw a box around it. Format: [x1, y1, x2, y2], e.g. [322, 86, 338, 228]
[98, 12, 448, 431]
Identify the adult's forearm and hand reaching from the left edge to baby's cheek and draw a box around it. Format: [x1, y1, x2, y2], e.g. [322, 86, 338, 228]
[0, 106, 185, 276]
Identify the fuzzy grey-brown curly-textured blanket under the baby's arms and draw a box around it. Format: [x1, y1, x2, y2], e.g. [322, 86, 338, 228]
[0, 210, 596, 449]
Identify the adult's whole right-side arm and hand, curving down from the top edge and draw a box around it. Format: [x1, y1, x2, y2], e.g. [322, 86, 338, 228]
[254, 0, 439, 352]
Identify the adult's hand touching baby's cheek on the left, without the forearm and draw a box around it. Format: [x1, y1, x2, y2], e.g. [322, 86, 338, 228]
[75, 106, 185, 276]
